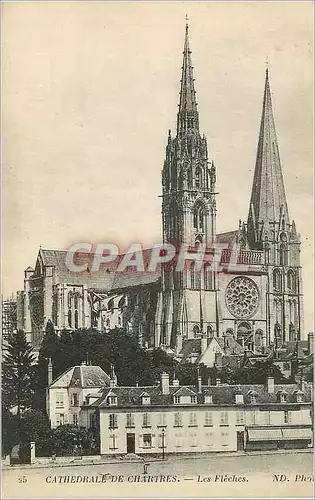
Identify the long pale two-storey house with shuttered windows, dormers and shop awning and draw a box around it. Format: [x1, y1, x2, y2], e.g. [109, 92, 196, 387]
[80, 373, 313, 456]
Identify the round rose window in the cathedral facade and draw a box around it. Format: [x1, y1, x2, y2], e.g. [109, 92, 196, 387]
[225, 277, 259, 318]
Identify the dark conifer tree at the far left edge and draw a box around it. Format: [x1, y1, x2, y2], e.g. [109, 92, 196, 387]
[2, 330, 35, 415]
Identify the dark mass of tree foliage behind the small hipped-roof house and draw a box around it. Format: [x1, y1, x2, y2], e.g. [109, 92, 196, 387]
[39, 329, 177, 390]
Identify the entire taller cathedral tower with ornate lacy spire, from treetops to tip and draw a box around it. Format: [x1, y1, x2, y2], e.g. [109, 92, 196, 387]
[155, 24, 216, 351]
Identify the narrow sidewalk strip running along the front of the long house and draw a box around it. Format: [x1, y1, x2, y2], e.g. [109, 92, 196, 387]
[2, 448, 313, 470]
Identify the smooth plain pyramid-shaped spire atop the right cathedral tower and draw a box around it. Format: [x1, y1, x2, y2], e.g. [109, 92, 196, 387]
[248, 69, 289, 243]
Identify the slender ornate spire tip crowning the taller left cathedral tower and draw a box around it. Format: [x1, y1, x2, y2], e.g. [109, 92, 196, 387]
[177, 23, 199, 135]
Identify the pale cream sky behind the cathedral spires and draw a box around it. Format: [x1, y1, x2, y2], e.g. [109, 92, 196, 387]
[2, 1, 313, 331]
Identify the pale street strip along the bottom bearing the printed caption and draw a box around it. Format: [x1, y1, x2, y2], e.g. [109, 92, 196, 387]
[2, 453, 313, 498]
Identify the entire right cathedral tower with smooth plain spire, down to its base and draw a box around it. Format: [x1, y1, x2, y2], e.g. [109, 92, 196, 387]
[247, 69, 303, 347]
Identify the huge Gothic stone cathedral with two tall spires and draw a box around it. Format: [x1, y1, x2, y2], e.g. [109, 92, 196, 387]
[17, 25, 304, 354]
